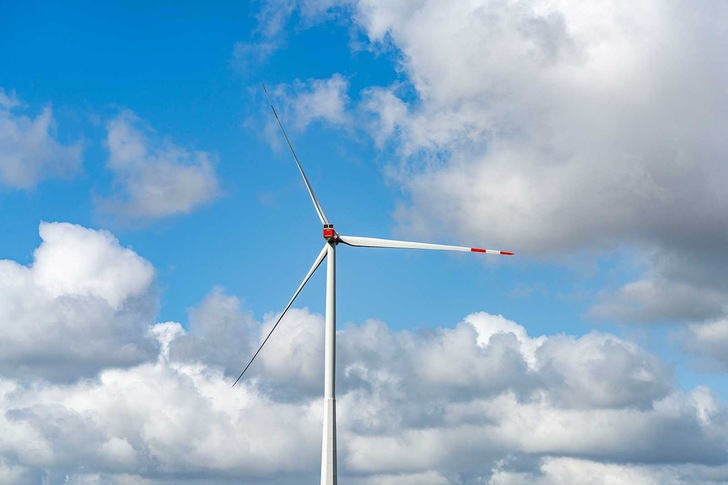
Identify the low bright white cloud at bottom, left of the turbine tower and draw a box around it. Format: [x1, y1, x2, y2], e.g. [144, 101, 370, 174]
[0, 359, 320, 483]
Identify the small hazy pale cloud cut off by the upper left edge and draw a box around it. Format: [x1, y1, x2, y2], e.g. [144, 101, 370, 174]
[0, 88, 83, 189]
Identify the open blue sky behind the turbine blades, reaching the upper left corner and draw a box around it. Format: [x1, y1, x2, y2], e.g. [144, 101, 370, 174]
[3, 3, 594, 332]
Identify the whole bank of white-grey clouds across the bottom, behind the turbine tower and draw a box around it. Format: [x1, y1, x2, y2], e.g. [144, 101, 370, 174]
[0, 223, 728, 484]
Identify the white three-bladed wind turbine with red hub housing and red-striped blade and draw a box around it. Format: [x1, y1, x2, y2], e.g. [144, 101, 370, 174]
[233, 84, 513, 485]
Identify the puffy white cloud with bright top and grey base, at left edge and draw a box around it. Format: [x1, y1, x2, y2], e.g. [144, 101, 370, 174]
[0, 222, 157, 381]
